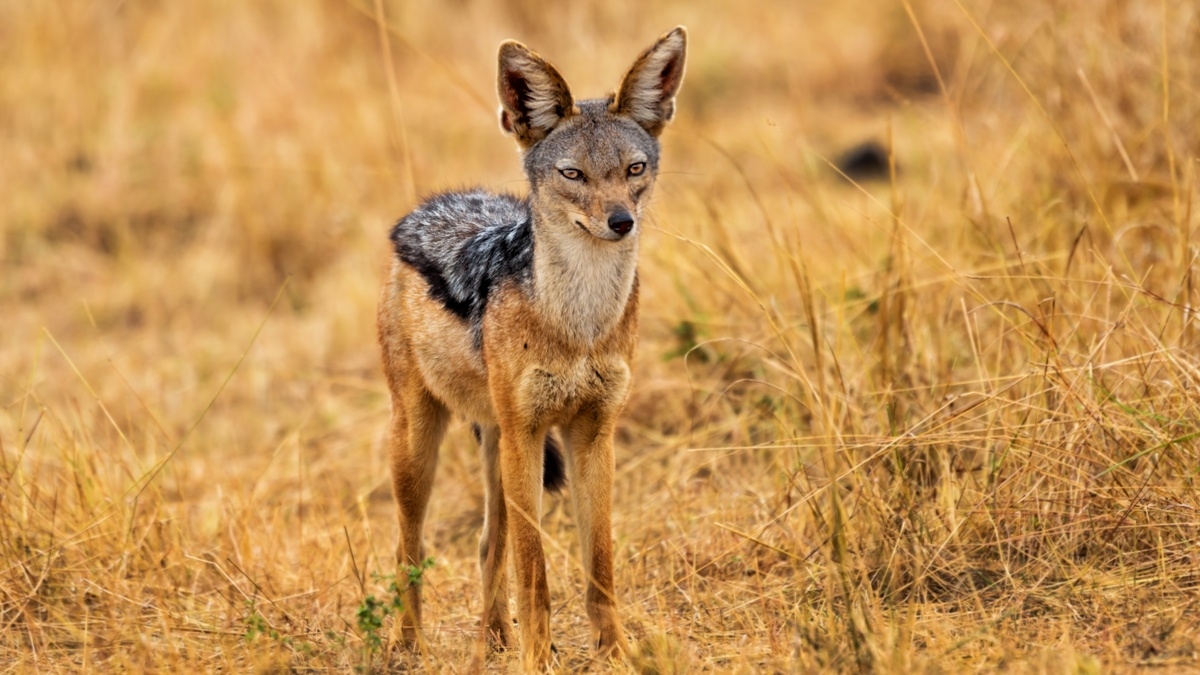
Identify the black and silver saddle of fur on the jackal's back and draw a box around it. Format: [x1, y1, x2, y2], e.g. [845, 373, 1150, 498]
[391, 190, 533, 338]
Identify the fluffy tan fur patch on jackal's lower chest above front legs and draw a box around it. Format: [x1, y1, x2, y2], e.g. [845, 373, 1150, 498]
[516, 354, 630, 425]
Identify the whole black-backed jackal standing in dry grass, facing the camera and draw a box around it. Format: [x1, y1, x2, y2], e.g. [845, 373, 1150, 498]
[378, 26, 686, 669]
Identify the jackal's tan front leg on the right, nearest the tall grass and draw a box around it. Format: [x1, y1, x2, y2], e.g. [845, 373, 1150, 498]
[566, 411, 628, 656]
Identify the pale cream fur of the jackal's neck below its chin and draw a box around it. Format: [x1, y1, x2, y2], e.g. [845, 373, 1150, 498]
[533, 215, 637, 347]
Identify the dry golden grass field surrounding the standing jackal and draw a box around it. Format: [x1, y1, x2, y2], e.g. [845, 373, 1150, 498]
[0, 0, 1200, 673]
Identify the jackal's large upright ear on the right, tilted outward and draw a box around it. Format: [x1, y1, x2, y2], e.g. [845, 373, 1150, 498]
[608, 25, 688, 136]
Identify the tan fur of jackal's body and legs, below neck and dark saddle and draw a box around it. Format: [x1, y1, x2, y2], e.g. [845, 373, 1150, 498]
[379, 257, 637, 664]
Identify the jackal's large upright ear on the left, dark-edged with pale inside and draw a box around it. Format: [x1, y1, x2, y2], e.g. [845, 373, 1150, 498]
[497, 40, 578, 149]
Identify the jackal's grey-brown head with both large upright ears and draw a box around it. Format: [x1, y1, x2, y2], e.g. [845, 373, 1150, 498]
[498, 26, 688, 241]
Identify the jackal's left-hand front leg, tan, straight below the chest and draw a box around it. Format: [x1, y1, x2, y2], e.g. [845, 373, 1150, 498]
[500, 426, 551, 670]
